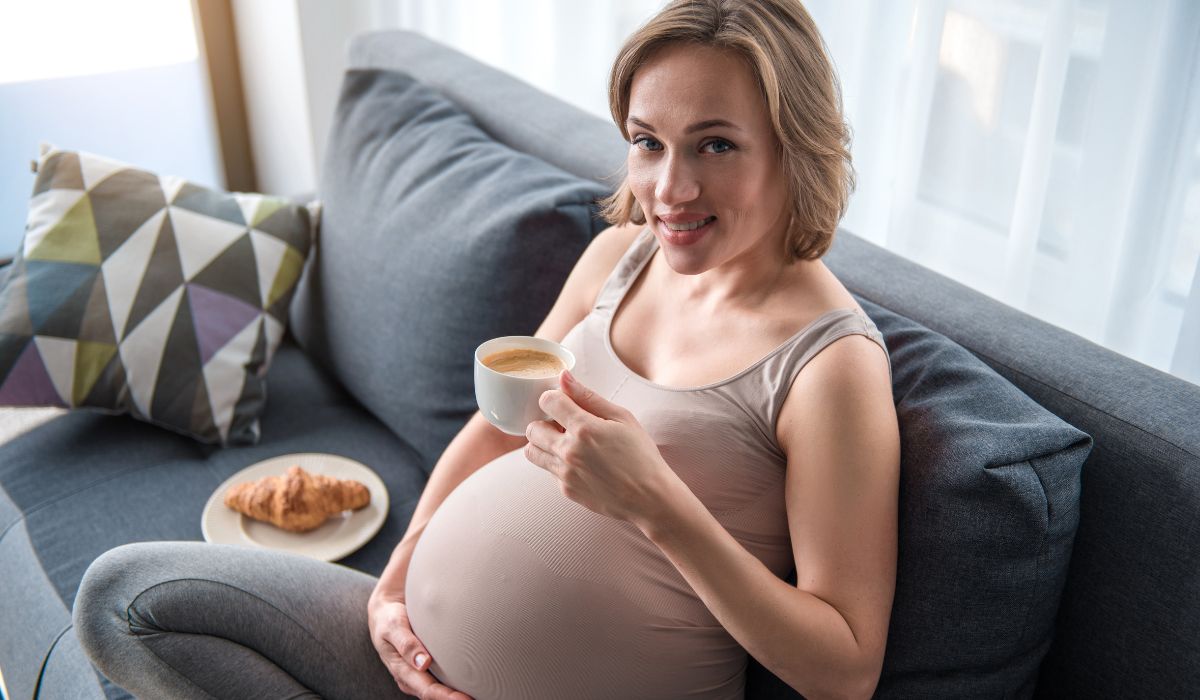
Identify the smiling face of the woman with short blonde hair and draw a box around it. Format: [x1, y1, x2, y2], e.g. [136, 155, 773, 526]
[625, 44, 788, 275]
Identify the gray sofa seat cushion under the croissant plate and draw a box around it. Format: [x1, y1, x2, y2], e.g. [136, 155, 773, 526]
[0, 340, 425, 698]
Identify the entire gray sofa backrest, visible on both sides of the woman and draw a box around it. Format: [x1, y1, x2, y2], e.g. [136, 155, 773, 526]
[349, 31, 1200, 695]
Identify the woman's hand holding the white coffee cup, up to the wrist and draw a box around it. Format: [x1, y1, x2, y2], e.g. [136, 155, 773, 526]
[524, 371, 678, 525]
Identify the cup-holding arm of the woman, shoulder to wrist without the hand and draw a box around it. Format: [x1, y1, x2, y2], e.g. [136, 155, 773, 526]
[638, 335, 900, 699]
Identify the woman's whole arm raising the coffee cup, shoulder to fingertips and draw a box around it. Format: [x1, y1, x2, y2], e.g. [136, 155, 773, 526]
[524, 335, 900, 699]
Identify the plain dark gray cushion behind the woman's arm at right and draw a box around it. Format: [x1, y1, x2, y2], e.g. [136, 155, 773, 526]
[748, 298, 1091, 698]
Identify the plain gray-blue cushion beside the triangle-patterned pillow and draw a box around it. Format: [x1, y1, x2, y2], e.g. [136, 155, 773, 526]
[292, 70, 607, 467]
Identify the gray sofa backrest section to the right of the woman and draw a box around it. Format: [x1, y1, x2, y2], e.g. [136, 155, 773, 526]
[826, 232, 1200, 698]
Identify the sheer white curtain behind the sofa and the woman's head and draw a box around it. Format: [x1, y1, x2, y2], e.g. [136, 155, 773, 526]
[376, 0, 1200, 383]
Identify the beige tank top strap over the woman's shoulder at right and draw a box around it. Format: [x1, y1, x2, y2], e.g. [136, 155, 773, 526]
[726, 307, 892, 454]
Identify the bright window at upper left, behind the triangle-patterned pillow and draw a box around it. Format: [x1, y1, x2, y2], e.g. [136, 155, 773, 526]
[0, 0, 223, 257]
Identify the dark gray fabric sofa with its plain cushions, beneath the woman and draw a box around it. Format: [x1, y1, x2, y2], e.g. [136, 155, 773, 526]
[0, 31, 1200, 700]
